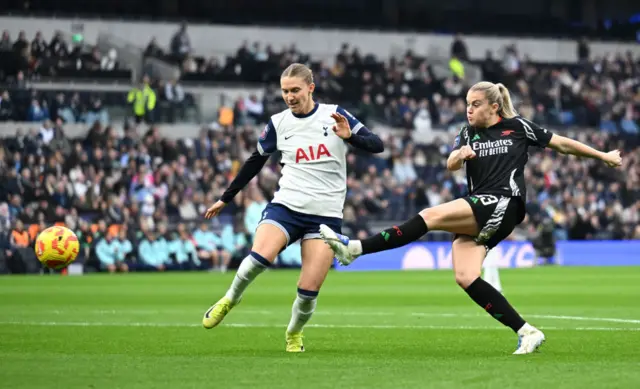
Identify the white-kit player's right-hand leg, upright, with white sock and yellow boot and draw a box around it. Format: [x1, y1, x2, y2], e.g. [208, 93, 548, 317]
[286, 239, 333, 352]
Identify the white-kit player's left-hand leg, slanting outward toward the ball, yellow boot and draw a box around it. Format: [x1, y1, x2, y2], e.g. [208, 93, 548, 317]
[202, 224, 287, 329]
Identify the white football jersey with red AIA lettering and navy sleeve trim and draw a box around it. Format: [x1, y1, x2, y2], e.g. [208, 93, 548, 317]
[258, 103, 363, 218]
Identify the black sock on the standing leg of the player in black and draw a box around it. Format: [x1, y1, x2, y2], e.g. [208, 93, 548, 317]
[465, 277, 525, 333]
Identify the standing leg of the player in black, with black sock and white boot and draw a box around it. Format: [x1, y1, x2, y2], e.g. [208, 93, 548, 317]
[452, 236, 544, 354]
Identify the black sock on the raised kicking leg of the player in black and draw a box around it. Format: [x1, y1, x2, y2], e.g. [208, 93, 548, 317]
[360, 215, 429, 254]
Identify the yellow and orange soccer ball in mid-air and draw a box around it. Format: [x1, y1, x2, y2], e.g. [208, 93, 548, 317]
[35, 226, 80, 269]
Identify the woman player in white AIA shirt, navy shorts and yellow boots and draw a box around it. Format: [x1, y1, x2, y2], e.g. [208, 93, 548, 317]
[202, 64, 384, 352]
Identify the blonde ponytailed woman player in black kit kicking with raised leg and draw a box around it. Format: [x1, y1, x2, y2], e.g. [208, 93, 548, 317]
[320, 82, 622, 354]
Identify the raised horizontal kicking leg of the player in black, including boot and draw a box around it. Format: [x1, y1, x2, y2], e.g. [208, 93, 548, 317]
[320, 199, 478, 265]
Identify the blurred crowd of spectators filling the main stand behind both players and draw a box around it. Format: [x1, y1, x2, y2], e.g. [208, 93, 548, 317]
[0, 27, 640, 271]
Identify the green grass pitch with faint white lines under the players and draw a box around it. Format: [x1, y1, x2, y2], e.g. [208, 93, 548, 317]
[0, 267, 640, 389]
